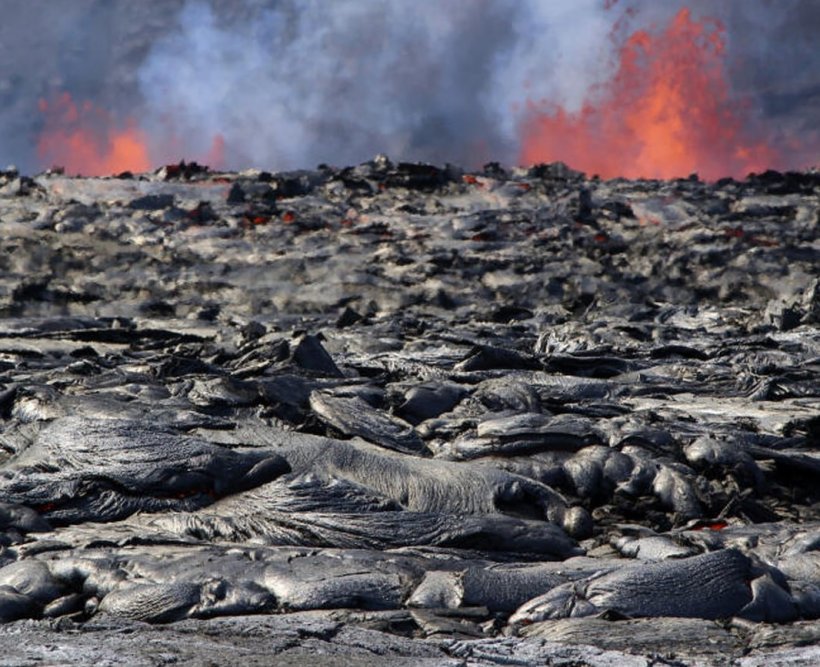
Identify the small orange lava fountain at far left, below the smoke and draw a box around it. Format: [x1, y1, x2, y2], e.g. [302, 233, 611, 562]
[37, 93, 151, 176]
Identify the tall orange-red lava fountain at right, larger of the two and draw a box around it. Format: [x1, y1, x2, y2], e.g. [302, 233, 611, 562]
[521, 9, 779, 180]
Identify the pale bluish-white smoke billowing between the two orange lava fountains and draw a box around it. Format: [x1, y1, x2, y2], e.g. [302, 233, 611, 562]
[140, 0, 613, 169]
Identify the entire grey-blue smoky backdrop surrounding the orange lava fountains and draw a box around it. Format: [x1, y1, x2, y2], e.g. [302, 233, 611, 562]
[0, 0, 820, 171]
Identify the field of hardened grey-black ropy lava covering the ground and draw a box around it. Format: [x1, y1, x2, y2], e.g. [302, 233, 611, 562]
[0, 157, 820, 665]
